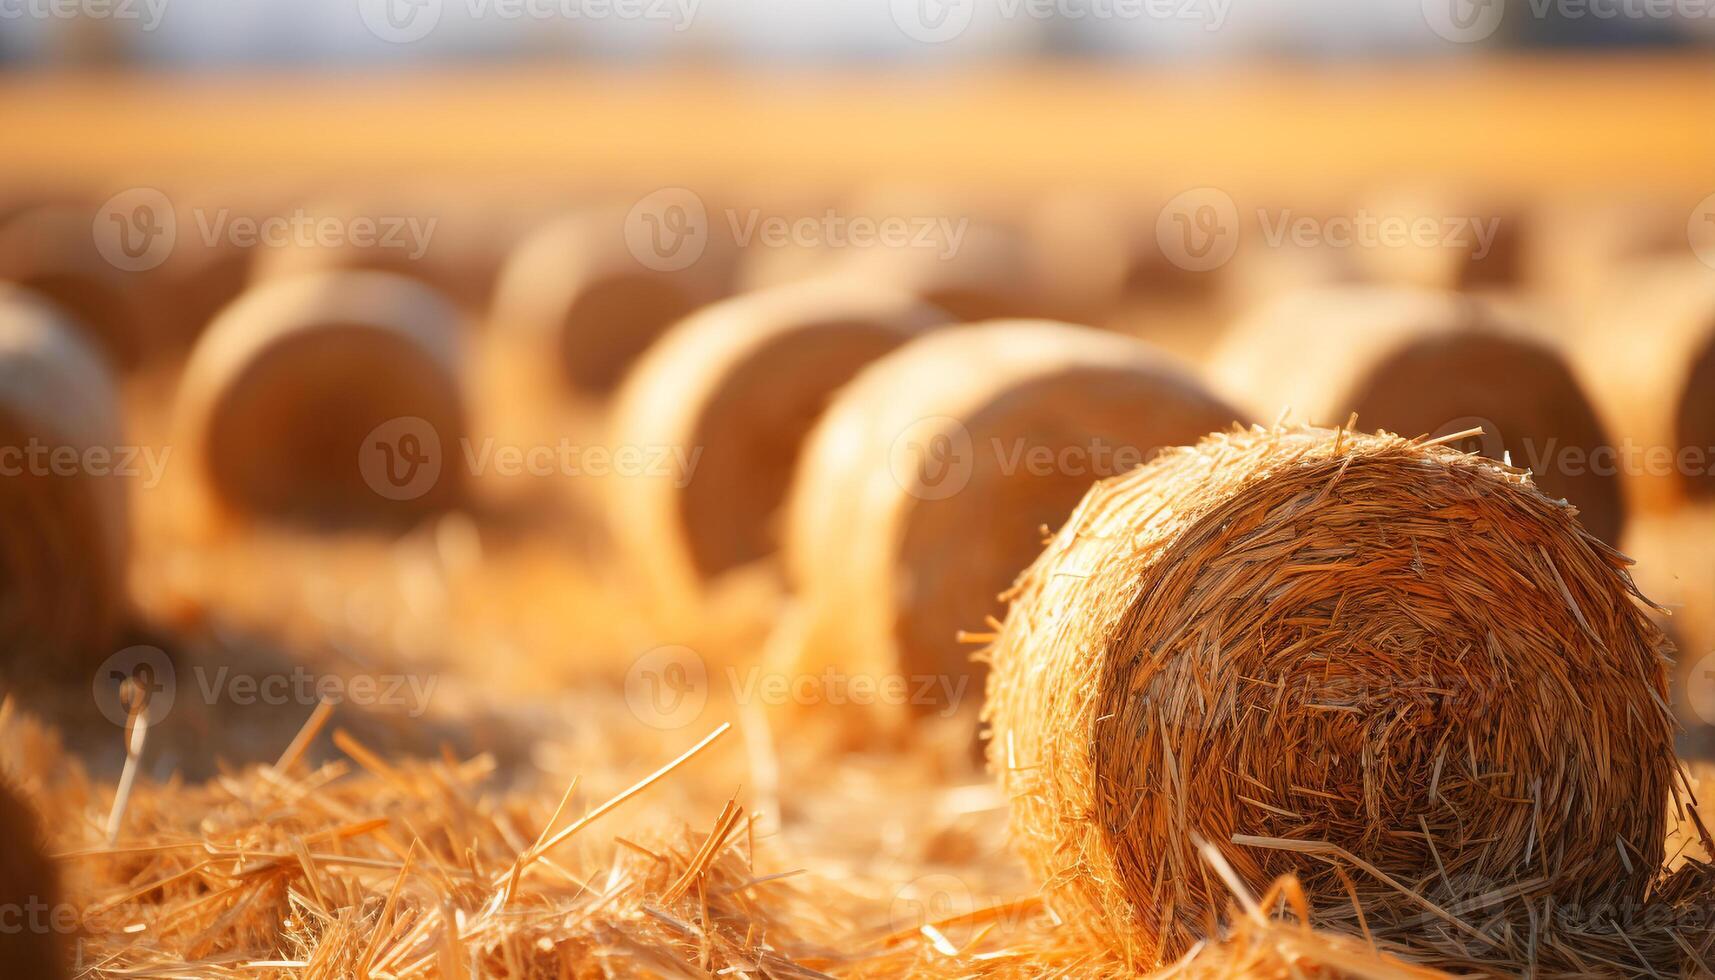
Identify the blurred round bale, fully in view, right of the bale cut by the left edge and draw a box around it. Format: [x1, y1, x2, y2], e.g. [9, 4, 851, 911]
[177, 273, 465, 525]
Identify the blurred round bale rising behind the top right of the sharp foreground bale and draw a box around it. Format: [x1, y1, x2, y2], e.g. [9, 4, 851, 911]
[1211, 287, 1626, 542]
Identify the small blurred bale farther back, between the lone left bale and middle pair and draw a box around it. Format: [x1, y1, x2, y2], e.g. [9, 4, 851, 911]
[492, 209, 734, 396]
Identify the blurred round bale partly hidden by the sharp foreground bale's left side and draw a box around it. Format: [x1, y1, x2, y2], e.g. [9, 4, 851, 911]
[785, 321, 1238, 721]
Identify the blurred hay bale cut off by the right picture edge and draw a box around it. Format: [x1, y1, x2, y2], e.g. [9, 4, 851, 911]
[1578, 257, 1715, 511]
